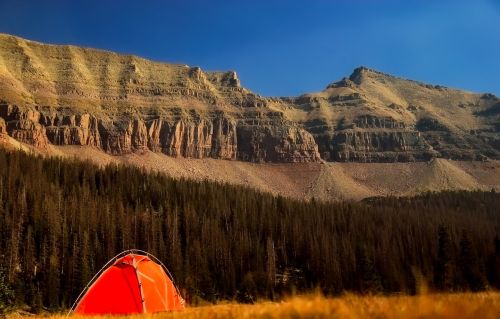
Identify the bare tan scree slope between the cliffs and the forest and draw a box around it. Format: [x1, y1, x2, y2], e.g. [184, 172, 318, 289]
[42, 146, 500, 200]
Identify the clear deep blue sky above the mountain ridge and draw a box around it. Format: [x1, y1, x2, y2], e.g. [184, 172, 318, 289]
[0, 0, 500, 96]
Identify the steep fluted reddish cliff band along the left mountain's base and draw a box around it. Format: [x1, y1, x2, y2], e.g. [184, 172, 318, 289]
[0, 104, 320, 163]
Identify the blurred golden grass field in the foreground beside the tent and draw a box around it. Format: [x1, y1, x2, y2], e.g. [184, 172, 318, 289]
[7, 292, 500, 319]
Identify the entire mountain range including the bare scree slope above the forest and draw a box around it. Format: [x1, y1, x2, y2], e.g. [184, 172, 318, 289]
[0, 35, 500, 199]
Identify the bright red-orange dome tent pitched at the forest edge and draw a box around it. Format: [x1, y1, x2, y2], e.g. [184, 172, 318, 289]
[70, 250, 185, 315]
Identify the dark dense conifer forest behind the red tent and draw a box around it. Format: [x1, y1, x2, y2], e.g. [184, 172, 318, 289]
[0, 150, 500, 311]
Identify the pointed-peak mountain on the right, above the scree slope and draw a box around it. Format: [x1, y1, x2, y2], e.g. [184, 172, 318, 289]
[292, 67, 500, 162]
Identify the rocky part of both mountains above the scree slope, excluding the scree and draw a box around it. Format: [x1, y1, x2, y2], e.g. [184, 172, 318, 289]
[0, 34, 500, 163]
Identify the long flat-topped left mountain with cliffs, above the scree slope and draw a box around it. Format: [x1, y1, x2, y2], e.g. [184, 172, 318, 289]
[0, 36, 319, 162]
